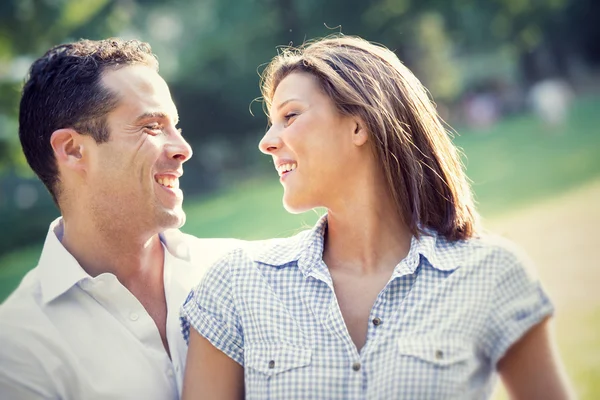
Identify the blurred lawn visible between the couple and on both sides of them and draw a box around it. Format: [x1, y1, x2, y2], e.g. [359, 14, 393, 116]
[0, 98, 600, 399]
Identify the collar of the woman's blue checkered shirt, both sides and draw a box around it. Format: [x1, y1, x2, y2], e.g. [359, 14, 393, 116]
[253, 214, 460, 276]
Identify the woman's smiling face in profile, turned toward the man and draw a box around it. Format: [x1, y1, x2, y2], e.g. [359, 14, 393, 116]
[259, 73, 360, 213]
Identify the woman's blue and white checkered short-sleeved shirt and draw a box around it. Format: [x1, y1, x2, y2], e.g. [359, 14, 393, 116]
[181, 216, 553, 400]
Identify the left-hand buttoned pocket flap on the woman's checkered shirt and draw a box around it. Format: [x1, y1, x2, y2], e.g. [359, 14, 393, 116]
[244, 343, 312, 375]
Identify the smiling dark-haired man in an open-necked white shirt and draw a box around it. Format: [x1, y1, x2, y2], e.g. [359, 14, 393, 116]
[0, 39, 237, 399]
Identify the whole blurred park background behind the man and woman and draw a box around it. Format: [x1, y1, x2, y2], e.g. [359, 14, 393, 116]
[0, 0, 600, 399]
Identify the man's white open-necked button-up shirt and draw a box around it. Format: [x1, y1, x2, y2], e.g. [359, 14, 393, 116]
[0, 218, 240, 400]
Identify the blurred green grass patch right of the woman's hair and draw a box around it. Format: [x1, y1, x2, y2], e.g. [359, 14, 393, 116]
[455, 98, 600, 215]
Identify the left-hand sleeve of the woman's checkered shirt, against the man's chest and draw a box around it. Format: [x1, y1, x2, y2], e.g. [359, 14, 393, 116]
[180, 250, 244, 366]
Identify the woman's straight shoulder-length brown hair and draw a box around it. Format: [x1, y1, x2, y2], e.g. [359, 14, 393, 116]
[261, 36, 477, 240]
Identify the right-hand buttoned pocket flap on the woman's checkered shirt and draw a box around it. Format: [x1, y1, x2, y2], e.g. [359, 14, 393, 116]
[397, 336, 470, 366]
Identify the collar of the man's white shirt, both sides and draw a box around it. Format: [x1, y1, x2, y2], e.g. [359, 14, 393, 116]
[38, 217, 191, 303]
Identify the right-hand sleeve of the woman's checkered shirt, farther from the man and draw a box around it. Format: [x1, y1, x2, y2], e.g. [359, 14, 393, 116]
[484, 248, 554, 366]
